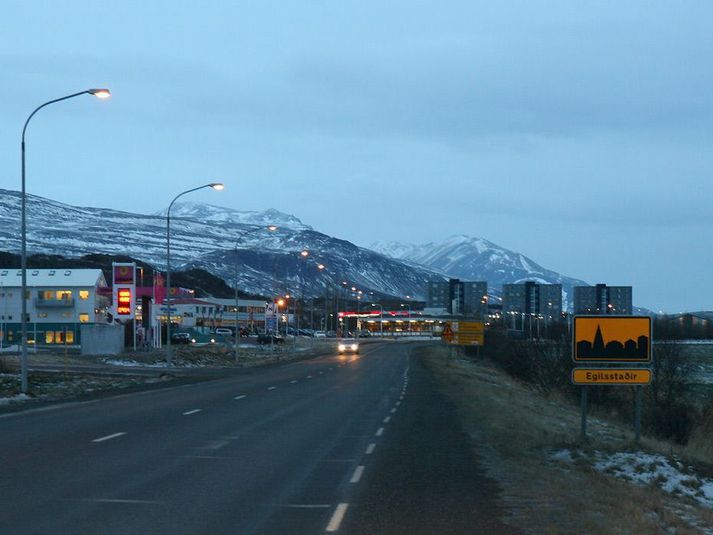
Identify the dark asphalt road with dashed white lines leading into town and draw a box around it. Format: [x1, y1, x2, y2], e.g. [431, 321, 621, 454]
[0, 343, 512, 534]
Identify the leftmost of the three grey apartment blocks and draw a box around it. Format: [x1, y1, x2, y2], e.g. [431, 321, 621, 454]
[426, 279, 488, 318]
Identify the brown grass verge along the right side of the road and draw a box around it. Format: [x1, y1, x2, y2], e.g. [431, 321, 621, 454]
[420, 347, 713, 534]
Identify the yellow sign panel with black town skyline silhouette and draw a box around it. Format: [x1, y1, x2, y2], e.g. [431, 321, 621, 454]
[572, 316, 652, 362]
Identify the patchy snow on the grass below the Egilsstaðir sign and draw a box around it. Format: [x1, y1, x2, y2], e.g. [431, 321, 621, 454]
[550, 449, 713, 509]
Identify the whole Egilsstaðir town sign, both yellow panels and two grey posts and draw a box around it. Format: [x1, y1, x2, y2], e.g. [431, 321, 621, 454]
[572, 316, 653, 442]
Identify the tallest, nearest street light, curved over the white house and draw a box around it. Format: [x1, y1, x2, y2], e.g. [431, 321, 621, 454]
[20, 89, 111, 394]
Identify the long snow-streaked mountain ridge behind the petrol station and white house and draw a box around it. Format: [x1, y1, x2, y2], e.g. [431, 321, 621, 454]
[0, 190, 442, 298]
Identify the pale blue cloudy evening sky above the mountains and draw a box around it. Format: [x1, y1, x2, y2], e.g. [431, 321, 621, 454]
[0, 0, 713, 312]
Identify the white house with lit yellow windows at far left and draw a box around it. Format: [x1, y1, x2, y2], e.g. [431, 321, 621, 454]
[0, 268, 111, 346]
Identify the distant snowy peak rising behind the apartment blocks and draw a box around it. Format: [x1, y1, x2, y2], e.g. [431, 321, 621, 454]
[369, 234, 587, 301]
